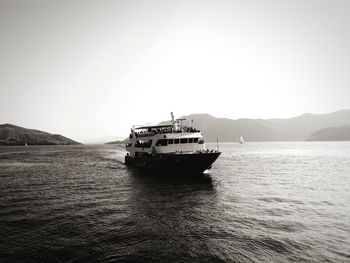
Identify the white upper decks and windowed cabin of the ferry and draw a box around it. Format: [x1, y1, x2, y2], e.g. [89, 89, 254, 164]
[126, 124, 205, 157]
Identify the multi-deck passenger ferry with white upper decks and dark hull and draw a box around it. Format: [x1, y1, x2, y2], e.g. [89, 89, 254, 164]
[125, 112, 221, 174]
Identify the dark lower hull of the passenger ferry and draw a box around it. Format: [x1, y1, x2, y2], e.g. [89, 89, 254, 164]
[125, 152, 221, 173]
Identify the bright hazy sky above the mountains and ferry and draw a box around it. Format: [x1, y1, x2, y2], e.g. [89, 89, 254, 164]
[0, 0, 350, 141]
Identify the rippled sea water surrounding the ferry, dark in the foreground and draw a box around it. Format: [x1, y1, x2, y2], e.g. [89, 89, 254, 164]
[0, 142, 350, 263]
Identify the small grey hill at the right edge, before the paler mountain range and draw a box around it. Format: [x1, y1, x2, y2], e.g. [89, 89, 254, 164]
[309, 125, 350, 141]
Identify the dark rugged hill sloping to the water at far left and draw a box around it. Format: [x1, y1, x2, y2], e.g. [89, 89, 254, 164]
[0, 124, 80, 145]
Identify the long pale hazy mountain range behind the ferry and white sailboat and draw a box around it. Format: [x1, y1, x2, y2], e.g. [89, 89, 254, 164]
[162, 110, 350, 142]
